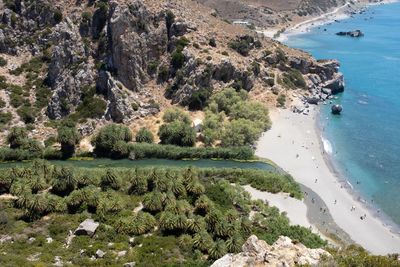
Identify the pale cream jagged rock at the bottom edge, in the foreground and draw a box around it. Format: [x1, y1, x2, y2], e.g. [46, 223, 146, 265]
[211, 235, 330, 267]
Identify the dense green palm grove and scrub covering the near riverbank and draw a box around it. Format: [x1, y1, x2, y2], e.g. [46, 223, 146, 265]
[0, 161, 318, 266]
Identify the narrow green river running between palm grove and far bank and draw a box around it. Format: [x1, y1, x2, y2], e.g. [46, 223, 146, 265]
[0, 159, 280, 171]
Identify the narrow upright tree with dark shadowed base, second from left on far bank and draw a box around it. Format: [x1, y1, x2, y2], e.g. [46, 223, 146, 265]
[57, 124, 81, 158]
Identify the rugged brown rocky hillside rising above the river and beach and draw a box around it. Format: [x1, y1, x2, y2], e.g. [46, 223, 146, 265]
[0, 0, 343, 142]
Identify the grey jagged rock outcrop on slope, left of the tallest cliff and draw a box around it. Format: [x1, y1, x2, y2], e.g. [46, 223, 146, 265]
[47, 18, 95, 119]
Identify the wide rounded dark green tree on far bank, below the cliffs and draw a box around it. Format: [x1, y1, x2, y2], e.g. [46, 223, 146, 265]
[92, 124, 132, 158]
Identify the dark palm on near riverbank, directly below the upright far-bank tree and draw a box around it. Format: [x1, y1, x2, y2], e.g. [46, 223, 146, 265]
[52, 167, 77, 196]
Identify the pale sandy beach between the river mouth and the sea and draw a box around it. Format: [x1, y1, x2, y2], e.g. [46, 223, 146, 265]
[256, 107, 400, 254]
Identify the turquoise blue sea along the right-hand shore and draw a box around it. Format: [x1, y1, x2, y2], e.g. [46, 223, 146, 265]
[286, 3, 400, 225]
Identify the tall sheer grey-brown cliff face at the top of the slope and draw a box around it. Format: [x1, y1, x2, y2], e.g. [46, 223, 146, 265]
[108, 1, 168, 92]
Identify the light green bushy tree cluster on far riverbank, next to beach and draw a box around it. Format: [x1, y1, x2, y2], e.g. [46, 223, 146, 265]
[203, 88, 271, 147]
